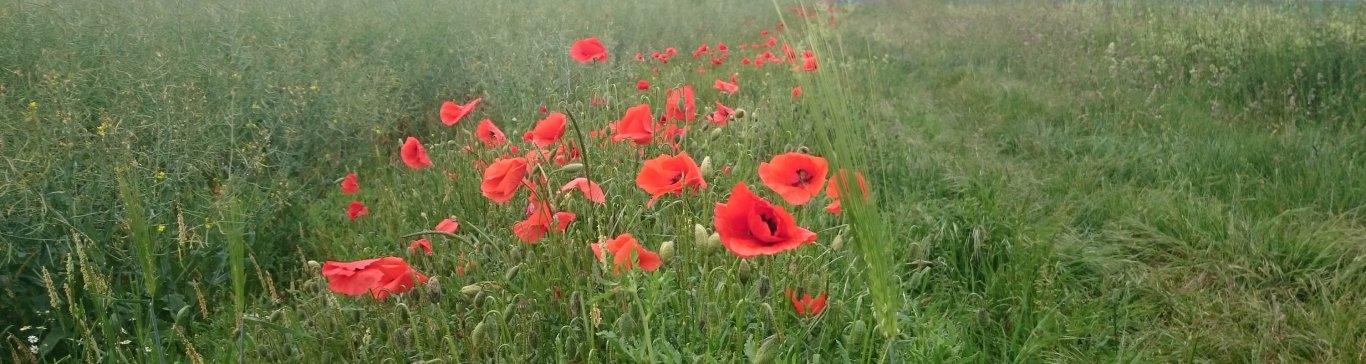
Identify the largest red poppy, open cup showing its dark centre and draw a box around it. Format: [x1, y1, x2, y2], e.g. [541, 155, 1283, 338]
[713, 182, 816, 259]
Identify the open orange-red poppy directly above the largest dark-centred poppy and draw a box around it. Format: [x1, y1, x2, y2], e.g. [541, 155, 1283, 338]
[759, 153, 829, 205]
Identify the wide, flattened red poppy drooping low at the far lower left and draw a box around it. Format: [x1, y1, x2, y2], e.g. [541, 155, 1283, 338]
[322, 257, 428, 300]
